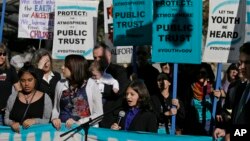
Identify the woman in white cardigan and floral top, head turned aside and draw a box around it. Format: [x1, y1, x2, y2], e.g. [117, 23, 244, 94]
[51, 55, 103, 129]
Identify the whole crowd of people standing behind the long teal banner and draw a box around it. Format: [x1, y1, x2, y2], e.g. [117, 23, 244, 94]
[0, 43, 250, 139]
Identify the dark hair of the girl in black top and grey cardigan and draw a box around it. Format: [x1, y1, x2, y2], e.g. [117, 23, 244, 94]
[17, 62, 39, 89]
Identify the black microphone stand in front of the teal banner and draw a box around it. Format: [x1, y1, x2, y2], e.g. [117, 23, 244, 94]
[60, 106, 121, 141]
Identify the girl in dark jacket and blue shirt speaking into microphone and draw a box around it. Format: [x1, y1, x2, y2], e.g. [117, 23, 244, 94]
[111, 80, 158, 133]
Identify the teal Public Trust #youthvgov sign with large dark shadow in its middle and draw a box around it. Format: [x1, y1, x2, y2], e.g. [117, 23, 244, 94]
[152, 0, 202, 64]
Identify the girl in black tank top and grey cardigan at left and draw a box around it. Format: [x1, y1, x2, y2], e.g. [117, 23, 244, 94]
[4, 63, 52, 132]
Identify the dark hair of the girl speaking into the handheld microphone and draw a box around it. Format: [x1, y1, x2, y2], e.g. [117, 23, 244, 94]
[128, 79, 152, 110]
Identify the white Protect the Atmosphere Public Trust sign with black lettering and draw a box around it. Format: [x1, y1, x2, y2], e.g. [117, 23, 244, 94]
[52, 0, 99, 59]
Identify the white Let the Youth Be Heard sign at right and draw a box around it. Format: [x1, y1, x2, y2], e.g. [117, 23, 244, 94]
[203, 0, 246, 63]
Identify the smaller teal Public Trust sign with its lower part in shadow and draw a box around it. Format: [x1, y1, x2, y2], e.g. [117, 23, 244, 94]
[113, 0, 153, 46]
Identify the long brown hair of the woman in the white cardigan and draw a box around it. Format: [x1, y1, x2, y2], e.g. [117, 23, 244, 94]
[64, 54, 89, 88]
